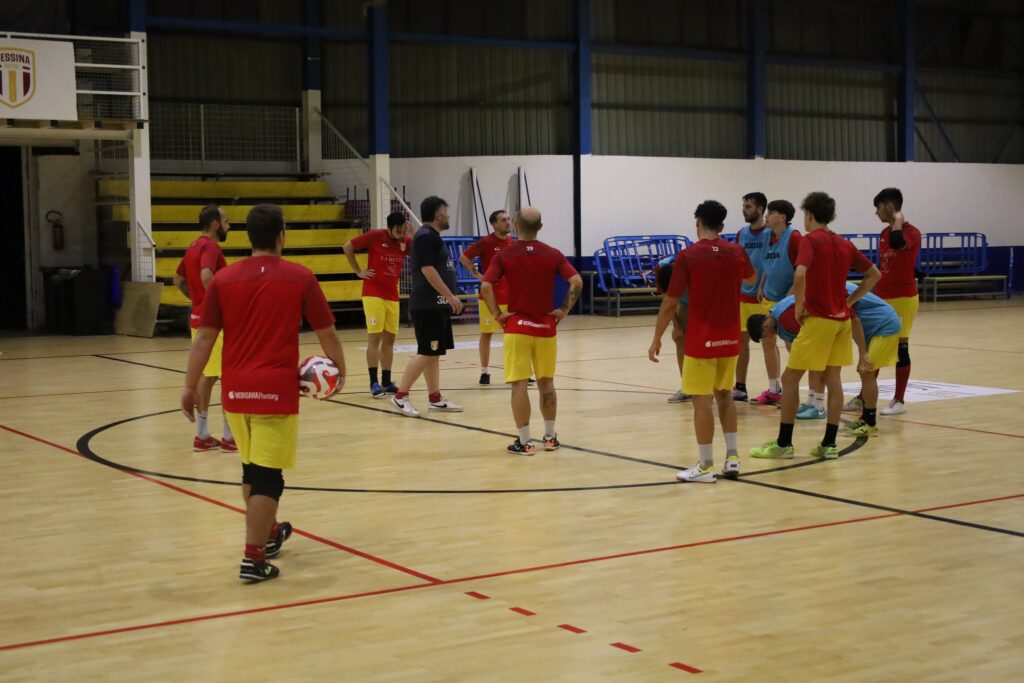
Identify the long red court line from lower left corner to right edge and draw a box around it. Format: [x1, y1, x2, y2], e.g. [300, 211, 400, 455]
[0, 491, 1024, 655]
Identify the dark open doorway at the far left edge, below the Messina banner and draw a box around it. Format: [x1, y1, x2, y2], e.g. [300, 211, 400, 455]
[0, 147, 29, 330]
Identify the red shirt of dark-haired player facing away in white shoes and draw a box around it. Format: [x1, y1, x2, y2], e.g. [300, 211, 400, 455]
[668, 238, 757, 358]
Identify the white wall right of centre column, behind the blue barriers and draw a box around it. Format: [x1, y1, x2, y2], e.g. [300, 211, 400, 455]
[583, 157, 1024, 250]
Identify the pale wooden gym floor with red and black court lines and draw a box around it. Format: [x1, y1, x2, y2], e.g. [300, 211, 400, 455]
[0, 299, 1024, 682]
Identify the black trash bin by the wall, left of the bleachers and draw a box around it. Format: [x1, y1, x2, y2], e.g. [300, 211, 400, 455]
[42, 266, 114, 335]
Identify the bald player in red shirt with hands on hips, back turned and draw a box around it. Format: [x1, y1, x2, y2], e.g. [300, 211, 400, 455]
[480, 207, 583, 456]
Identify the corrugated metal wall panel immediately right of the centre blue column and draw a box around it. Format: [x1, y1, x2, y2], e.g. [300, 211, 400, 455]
[593, 54, 746, 158]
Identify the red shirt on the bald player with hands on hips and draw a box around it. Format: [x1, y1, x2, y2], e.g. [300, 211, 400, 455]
[483, 240, 577, 337]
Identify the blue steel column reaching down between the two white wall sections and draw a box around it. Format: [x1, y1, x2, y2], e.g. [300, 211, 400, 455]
[572, 0, 593, 265]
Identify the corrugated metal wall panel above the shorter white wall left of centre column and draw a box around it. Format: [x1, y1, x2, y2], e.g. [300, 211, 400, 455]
[390, 44, 571, 157]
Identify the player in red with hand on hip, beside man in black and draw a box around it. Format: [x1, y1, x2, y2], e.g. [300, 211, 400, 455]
[342, 212, 413, 398]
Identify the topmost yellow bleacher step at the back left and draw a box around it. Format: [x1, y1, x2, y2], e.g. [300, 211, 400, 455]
[98, 180, 334, 200]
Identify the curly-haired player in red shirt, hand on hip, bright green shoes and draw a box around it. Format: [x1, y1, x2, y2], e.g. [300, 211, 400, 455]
[751, 193, 882, 459]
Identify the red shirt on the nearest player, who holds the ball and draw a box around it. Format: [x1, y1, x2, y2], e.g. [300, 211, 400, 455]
[200, 256, 334, 415]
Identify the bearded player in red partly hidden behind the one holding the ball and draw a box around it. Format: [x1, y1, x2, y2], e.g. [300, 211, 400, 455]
[174, 204, 239, 453]
